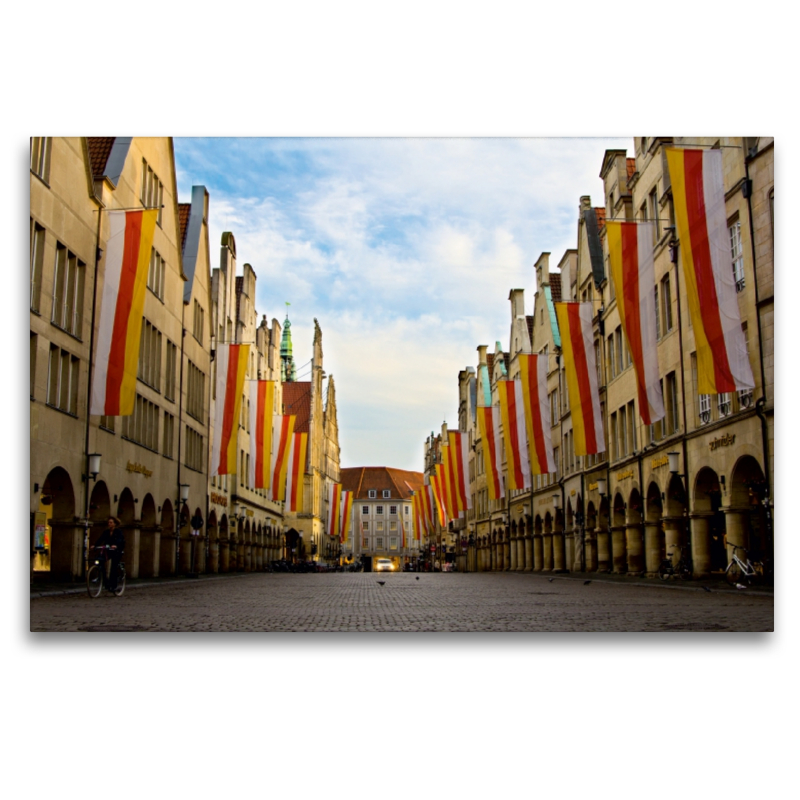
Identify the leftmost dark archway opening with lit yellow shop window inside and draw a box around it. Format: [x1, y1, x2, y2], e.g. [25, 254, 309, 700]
[36, 467, 77, 579]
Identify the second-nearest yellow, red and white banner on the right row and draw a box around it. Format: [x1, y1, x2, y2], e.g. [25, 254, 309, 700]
[606, 221, 664, 425]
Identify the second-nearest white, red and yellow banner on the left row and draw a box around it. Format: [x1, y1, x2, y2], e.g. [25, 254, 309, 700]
[211, 344, 250, 477]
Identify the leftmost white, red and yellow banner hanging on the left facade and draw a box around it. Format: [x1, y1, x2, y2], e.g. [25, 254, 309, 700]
[90, 209, 158, 417]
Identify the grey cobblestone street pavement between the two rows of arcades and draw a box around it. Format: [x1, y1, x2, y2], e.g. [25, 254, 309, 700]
[30, 573, 774, 632]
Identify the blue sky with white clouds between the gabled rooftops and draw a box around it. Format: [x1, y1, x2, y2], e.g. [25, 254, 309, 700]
[175, 138, 633, 470]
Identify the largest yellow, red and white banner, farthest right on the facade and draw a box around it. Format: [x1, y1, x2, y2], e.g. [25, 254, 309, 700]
[666, 147, 755, 394]
